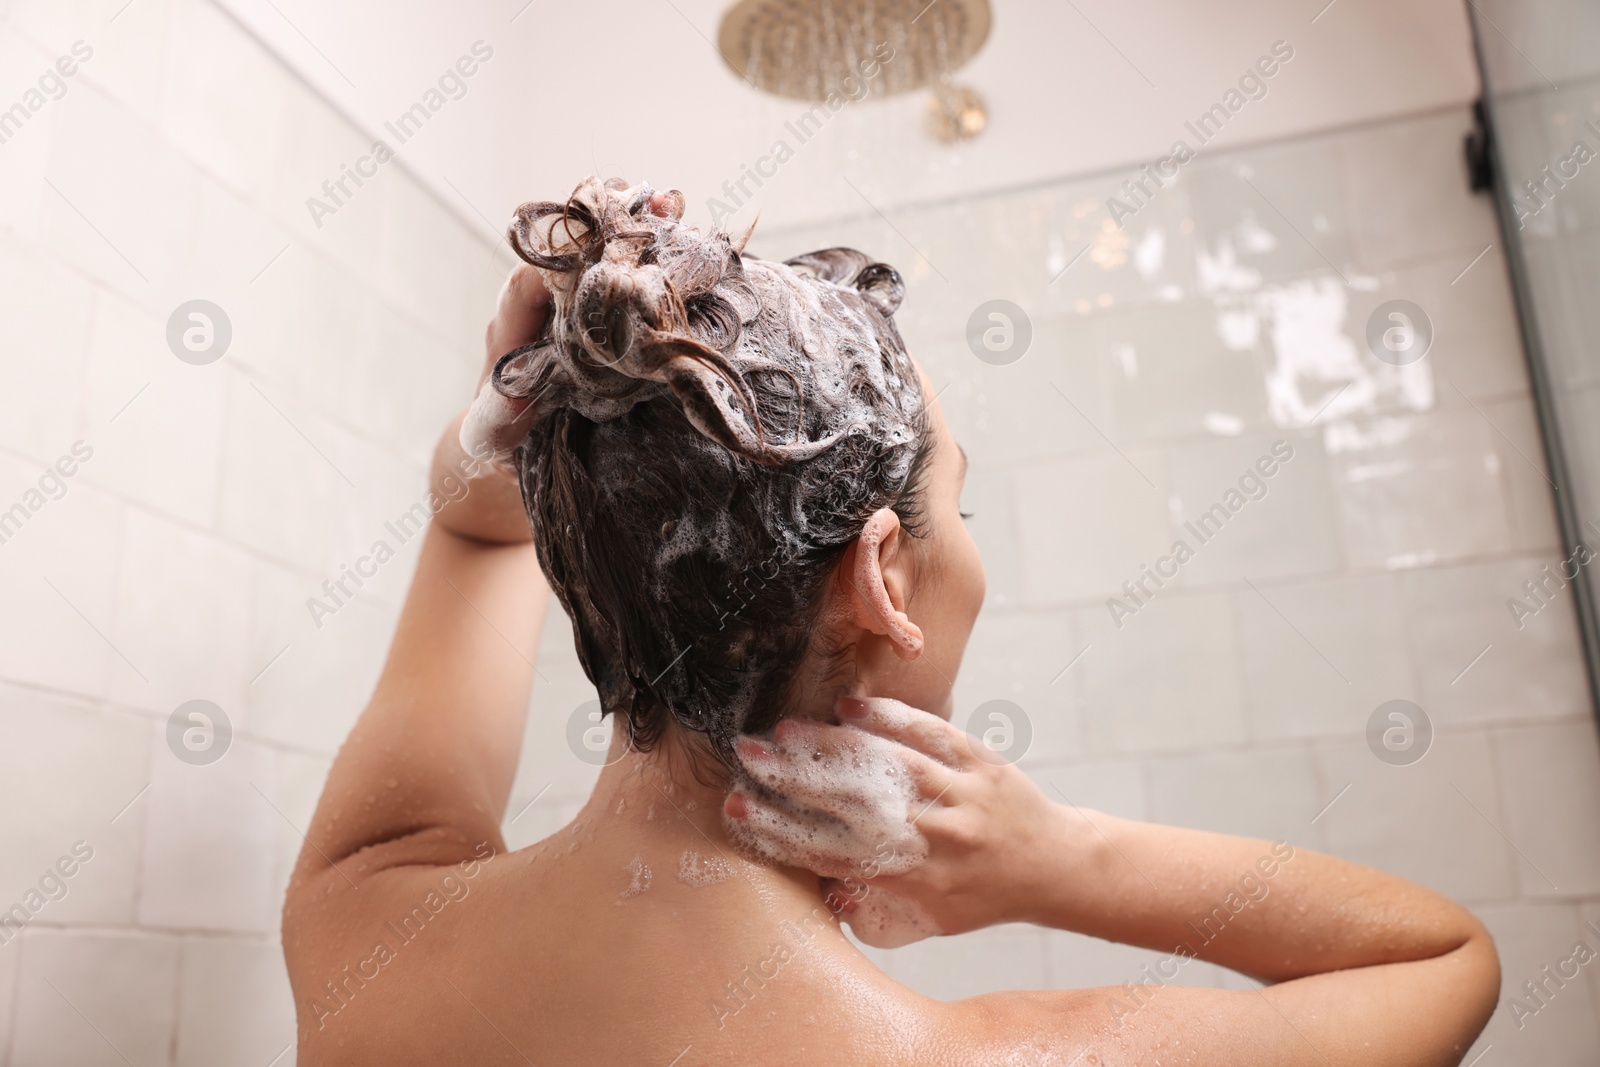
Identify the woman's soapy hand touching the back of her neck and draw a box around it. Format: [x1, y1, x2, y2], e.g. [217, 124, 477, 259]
[723, 697, 1072, 947]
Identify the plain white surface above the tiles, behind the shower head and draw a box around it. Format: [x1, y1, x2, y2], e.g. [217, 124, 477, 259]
[221, 0, 1477, 230]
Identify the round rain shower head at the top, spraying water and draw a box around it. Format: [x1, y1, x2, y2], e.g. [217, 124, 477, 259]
[717, 0, 989, 101]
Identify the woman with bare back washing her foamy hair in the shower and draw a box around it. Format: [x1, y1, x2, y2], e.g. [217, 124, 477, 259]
[283, 179, 1499, 1067]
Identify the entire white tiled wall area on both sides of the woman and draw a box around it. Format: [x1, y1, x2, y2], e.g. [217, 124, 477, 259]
[0, 0, 1600, 1065]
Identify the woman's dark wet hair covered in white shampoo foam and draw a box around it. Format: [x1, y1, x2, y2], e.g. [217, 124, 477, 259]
[493, 178, 931, 766]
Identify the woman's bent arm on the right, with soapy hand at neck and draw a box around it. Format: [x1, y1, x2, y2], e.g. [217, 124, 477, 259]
[726, 699, 1499, 1064]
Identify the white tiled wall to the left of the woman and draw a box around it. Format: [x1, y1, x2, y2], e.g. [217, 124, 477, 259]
[0, 0, 496, 1067]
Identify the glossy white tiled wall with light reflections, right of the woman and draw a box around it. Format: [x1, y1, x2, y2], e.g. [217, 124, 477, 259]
[790, 110, 1600, 1036]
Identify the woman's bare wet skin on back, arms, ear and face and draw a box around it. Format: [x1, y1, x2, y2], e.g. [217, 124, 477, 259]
[283, 260, 1499, 1067]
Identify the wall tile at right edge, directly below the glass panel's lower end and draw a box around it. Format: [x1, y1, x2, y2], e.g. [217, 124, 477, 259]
[1493, 720, 1600, 897]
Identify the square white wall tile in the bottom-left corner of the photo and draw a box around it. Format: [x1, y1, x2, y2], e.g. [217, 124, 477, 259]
[11, 929, 178, 1067]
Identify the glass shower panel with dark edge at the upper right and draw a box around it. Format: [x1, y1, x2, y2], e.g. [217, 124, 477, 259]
[1467, 0, 1600, 716]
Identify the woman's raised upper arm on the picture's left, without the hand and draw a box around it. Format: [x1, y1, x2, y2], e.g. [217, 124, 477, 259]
[298, 523, 549, 880]
